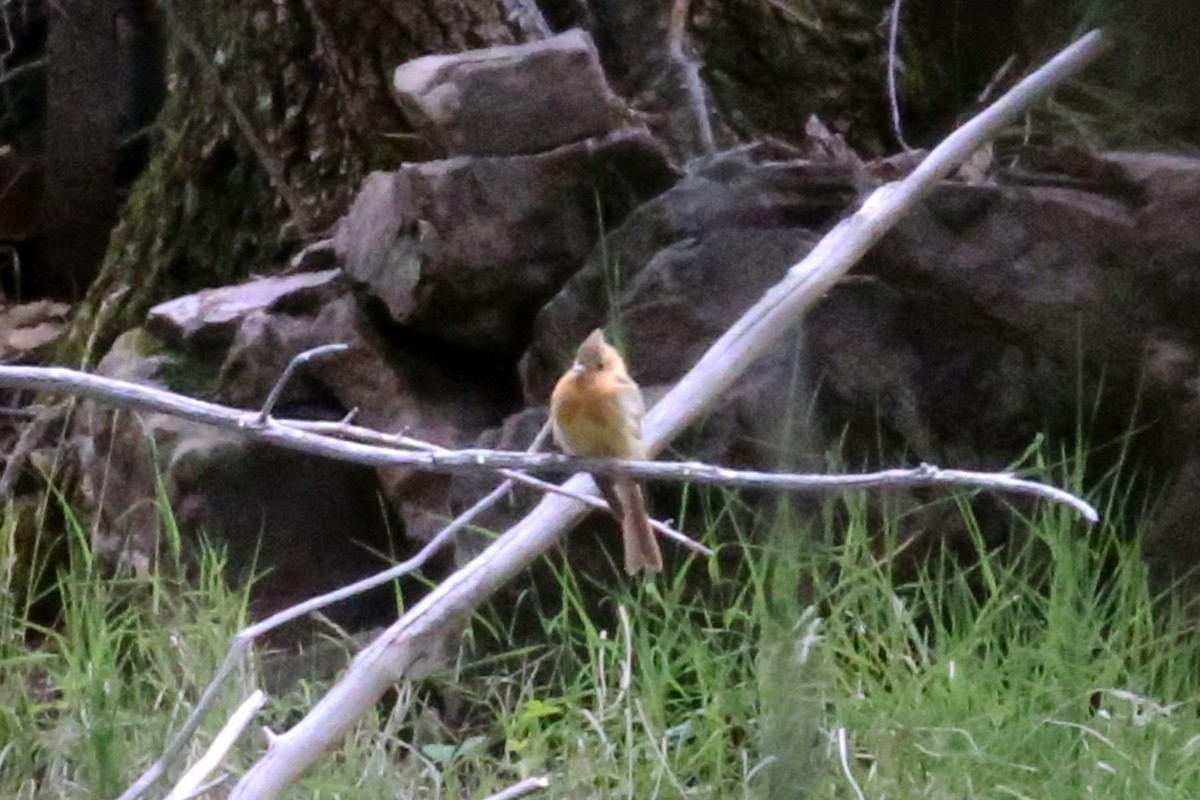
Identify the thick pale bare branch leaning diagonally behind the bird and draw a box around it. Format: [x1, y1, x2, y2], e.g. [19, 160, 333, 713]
[230, 30, 1109, 800]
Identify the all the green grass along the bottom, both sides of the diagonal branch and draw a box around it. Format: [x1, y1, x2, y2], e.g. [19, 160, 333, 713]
[0, 443, 1200, 799]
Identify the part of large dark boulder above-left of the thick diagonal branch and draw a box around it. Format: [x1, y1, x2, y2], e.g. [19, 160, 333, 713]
[521, 146, 864, 404]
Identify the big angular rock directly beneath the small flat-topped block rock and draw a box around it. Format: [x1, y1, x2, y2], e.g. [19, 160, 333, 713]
[335, 128, 676, 355]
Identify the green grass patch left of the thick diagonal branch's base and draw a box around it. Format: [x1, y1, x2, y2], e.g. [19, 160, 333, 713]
[0, 506, 250, 798]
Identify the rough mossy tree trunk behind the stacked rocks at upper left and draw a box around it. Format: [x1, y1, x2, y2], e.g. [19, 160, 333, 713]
[58, 0, 515, 365]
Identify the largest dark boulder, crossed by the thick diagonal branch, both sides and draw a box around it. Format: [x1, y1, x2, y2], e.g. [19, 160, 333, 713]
[521, 145, 1200, 585]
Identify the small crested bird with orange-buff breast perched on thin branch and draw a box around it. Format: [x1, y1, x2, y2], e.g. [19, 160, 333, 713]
[550, 329, 662, 575]
